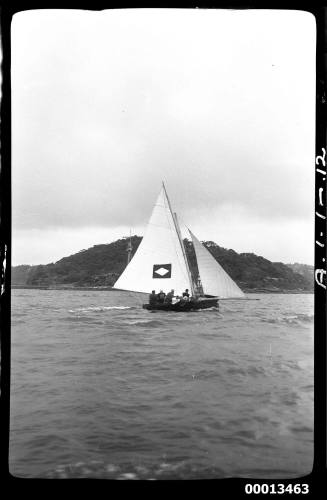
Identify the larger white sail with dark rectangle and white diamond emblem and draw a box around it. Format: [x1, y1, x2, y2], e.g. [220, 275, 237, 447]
[114, 187, 191, 295]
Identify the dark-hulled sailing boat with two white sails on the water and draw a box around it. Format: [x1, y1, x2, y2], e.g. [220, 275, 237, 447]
[114, 183, 244, 311]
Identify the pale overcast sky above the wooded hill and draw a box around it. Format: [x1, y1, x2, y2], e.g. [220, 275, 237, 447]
[12, 9, 316, 265]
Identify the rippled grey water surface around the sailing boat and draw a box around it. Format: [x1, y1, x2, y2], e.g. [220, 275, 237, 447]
[10, 290, 313, 479]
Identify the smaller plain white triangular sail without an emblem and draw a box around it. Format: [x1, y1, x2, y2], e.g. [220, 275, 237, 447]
[189, 230, 244, 298]
